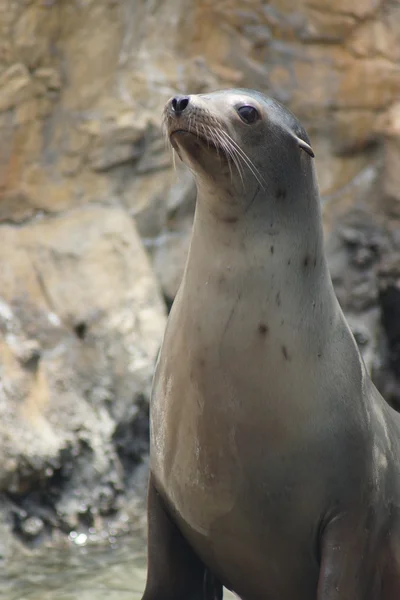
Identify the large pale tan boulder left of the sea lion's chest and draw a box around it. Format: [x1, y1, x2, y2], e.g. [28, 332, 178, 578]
[0, 206, 165, 505]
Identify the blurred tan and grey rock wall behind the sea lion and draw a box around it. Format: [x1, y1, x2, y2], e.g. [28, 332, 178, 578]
[0, 0, 400, 553]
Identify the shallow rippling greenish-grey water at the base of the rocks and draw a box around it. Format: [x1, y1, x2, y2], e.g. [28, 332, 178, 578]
[0, 536, 235, 600]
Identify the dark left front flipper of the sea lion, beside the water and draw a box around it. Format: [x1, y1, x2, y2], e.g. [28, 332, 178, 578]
[142, 474, 222, 600]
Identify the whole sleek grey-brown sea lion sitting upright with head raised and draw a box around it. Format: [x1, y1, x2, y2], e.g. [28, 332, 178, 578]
[143, 90, 400, 600]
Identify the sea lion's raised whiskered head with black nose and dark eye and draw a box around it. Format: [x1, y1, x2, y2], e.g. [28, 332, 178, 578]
[164, 89, 315, 221]
